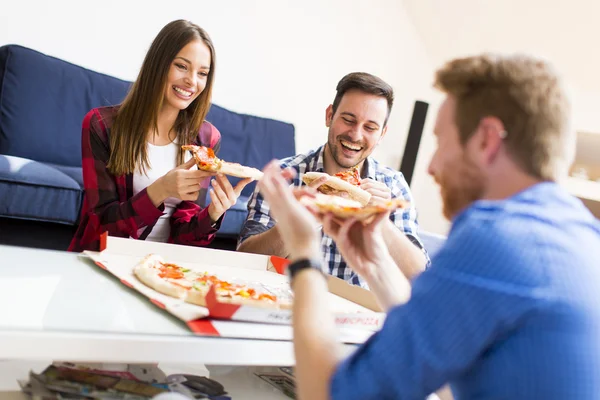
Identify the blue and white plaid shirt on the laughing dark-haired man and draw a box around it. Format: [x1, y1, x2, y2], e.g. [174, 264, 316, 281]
[238, 146, 429, 288]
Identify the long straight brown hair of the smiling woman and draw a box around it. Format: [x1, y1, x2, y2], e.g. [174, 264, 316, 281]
[108, 20, 215, 176]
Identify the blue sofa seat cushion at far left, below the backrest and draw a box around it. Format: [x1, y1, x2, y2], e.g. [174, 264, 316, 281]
[0, 154, 83, 225]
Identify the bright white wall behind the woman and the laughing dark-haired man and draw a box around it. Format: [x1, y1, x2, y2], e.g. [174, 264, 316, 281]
[0, 0, 440, 234]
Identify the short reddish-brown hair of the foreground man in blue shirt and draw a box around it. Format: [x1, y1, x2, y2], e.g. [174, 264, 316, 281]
[434, 54, 575, 180]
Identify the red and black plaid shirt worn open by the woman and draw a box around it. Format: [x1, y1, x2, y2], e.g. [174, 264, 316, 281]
[69, 106, 222, 252]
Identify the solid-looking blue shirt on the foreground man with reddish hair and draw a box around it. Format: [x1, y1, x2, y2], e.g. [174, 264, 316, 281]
[330, 183, 600, 400]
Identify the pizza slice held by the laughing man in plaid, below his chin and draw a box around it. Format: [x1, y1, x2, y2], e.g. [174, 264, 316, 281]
[302, 167, 371, 206]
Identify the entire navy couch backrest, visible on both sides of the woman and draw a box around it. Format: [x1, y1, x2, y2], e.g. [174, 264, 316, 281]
[0, 45, 295, 194]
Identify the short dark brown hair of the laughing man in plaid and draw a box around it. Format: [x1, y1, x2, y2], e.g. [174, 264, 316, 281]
[332, 72, 394, 126]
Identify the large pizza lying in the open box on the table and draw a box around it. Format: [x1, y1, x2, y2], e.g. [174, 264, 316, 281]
[133, 254, 291, 308]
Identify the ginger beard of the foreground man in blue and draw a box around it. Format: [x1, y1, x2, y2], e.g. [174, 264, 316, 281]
[435, 155, 485, 220]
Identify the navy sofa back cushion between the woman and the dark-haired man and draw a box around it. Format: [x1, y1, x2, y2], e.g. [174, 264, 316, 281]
[206, 104, 296, 196]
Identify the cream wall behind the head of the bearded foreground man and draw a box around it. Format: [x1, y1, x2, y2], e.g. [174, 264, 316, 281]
[402, 0, 600, 231]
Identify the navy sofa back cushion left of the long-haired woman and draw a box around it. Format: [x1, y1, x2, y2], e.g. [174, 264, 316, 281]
[0, 45, 130, 167]
